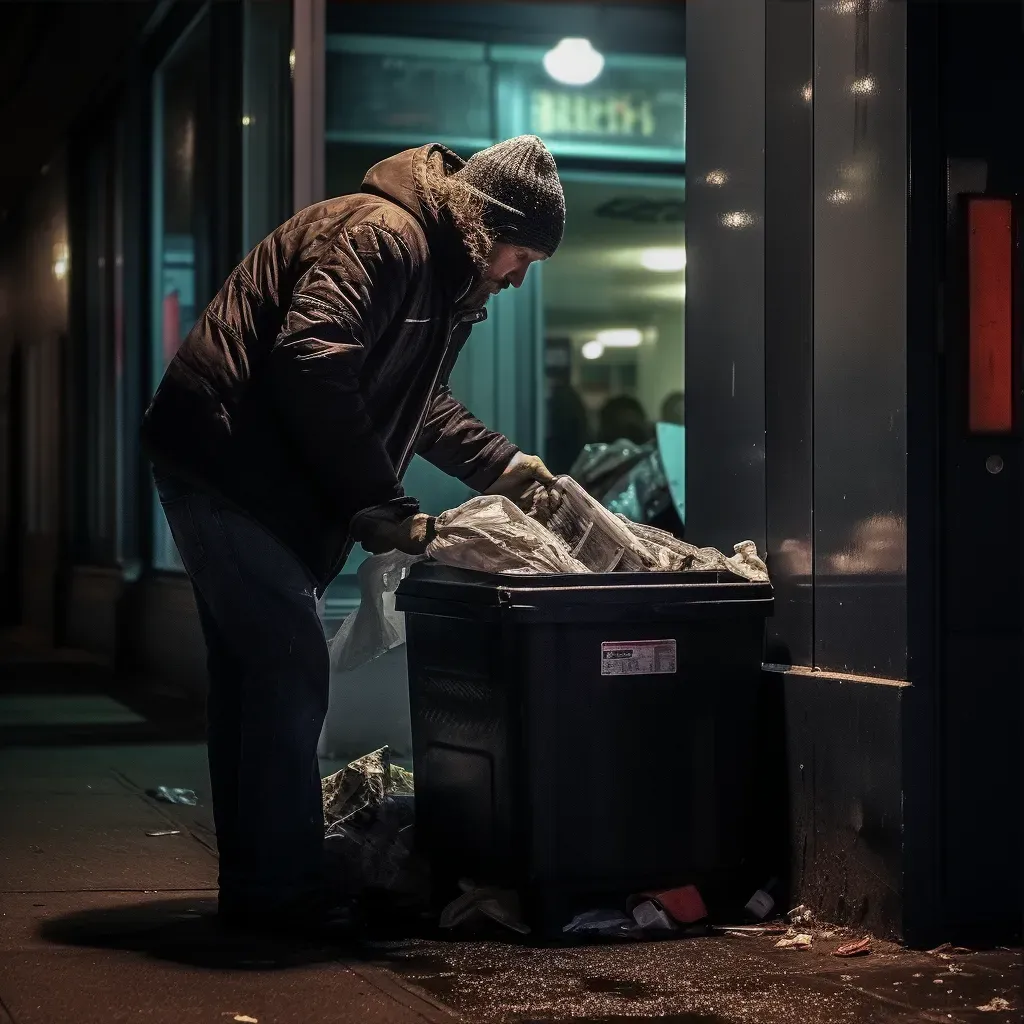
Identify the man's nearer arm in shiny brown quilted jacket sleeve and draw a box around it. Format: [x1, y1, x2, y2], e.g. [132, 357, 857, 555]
[268, 224, 415, 521]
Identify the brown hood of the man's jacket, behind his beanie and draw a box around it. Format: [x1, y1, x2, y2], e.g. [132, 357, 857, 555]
[362, 142, 474, 288]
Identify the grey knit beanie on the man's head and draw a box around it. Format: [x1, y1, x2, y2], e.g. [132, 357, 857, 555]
[455, 135, 565, 256]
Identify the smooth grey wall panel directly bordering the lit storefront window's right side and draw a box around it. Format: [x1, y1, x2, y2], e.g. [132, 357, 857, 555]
[686, 0, 765, 551]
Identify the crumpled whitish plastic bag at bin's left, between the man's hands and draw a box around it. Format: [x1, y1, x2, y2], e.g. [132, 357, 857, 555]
[427, 495, 588, 573]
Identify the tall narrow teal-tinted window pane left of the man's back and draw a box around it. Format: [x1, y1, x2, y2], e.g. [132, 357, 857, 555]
[151, 16, 211, 569]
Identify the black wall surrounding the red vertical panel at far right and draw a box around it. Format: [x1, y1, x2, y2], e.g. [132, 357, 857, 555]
[938, 3, 1024, 938]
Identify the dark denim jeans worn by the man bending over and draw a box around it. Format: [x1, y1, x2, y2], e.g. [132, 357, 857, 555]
[157, 474, 330, 906]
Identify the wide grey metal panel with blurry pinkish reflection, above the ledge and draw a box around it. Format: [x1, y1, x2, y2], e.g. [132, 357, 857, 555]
[813, 2, 907, 679]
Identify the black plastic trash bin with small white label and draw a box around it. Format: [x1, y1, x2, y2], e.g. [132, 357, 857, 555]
[396, 562, 773, 935]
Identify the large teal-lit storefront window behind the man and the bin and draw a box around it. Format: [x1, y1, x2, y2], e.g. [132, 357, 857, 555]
[325, 4, 685, 587]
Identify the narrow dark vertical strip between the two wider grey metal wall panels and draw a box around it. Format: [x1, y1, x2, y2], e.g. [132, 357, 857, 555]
[764, 0, 814, 666]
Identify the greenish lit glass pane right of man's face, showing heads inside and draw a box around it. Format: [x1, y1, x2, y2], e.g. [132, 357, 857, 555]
[544, 173, 686, 532]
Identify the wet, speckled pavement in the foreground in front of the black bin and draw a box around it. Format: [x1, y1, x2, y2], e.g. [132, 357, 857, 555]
[370, 936, 1022, 1024]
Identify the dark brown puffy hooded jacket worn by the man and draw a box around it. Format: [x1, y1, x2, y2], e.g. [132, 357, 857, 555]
[142, 145, 517, 587]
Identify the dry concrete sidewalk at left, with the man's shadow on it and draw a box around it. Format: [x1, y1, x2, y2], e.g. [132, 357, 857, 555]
[0, 643, 453, 1024]
